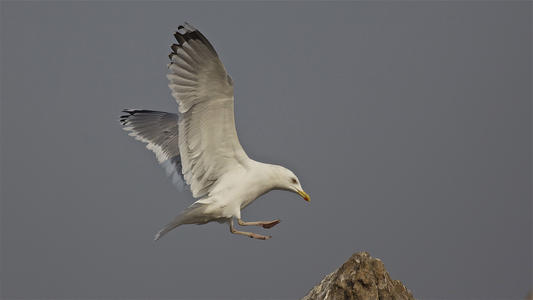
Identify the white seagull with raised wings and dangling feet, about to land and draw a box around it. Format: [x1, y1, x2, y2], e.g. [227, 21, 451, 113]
[120, 22, 310, 240]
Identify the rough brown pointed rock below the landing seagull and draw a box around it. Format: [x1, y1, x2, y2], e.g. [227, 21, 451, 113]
[302, 252, 414, 300]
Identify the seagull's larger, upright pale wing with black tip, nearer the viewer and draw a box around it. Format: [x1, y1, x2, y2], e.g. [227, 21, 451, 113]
[167, 23, 248, 198]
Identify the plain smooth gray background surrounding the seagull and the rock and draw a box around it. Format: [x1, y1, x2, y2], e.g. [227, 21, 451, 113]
[1, 1, 532, 299]
